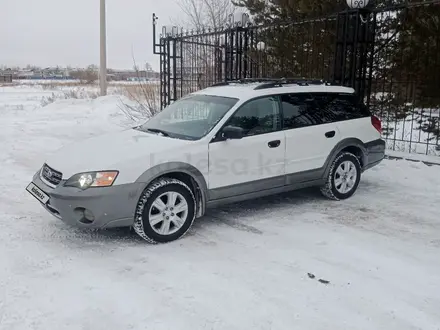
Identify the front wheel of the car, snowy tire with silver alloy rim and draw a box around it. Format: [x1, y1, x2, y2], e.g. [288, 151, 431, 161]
[133, 178, 196, 244]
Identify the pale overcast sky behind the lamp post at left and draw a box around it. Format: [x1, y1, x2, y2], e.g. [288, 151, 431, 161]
[0, 0, 180, 69]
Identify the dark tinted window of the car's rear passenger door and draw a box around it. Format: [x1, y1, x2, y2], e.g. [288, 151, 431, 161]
[281, 93, 322, 129]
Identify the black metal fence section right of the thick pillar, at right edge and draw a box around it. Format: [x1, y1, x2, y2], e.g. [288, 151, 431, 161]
[368, 1, 440, 156]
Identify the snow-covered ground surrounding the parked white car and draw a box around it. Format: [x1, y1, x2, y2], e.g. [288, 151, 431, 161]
[0, 86, 440, 330]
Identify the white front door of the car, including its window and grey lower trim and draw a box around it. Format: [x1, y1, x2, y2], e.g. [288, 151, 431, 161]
[208, 97, 285, 200]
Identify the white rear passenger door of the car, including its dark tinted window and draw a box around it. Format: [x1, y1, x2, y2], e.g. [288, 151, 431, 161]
[280, 93, 341, 177]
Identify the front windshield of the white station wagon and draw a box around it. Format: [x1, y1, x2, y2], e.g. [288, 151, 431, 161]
[138, 95, 238, 140]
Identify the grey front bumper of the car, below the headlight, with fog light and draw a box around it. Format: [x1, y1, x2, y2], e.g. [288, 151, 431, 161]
[32, 171, 143, 228]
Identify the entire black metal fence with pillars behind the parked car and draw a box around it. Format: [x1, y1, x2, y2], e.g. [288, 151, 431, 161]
[153, 0, 440, 155]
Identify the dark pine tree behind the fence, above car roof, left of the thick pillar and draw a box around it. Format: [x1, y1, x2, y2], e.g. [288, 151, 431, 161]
[233, 0, 346, 79]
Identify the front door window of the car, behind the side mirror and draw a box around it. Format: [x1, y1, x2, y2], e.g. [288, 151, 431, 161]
[228, 97, 281, 136]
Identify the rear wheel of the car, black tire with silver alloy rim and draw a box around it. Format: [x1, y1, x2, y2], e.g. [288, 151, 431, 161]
[321, 152, 362, 200]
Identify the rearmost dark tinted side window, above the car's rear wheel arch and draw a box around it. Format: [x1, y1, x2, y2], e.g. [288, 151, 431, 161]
[314, 94, 370, 123]
